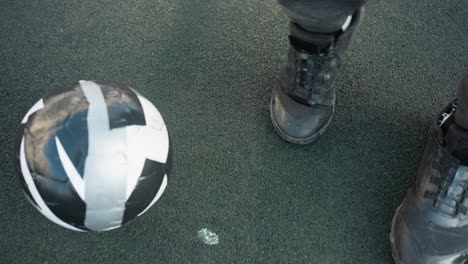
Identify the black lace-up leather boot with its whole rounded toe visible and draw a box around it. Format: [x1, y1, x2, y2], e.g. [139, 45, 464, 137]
[270, 9, 363, 144]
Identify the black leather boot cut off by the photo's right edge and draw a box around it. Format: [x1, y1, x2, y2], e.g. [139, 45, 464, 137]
[390, 75, 468, 264]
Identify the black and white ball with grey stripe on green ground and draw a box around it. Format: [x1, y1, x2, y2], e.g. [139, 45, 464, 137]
[15, 81, 171, 231]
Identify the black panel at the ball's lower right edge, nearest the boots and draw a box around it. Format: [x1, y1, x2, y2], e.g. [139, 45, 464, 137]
[122, 159, 165, 223]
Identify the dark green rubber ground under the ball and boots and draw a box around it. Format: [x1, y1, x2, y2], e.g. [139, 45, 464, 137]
[0, 0, 468, 264]
